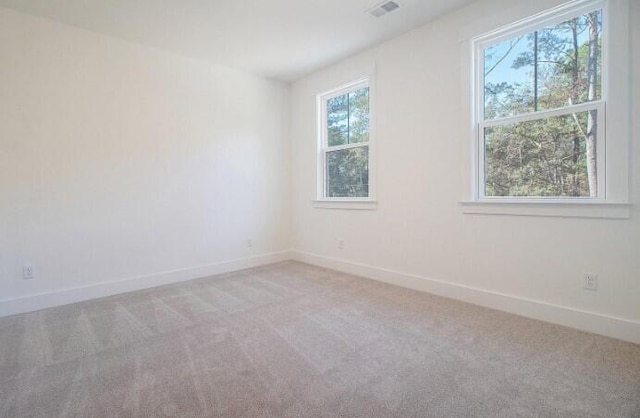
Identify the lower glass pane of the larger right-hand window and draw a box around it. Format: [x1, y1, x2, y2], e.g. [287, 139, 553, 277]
[484, 110, 598, 197]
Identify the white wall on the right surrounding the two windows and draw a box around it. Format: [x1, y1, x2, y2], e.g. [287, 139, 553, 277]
[291, 0, 640, 342]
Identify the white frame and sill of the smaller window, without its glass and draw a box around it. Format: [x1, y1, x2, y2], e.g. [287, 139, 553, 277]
[314, 76, 377, 209]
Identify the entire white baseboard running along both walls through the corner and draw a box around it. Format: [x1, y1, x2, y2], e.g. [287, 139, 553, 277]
[0, 251, 640, 344]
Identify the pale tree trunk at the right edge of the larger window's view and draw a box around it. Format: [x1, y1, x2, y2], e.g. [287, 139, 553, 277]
[587, 12, 598, 197]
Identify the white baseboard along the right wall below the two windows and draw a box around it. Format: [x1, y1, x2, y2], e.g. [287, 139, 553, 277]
[291, 251, 640, 344]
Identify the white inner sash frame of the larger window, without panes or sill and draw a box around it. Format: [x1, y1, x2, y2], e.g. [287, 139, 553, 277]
[467, 0, 611, 202]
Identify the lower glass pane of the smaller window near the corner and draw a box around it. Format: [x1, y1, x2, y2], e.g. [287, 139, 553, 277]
[326, 146, 369, 197]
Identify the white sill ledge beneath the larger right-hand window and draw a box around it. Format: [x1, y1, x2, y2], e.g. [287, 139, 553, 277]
[460, 200, 631, 219]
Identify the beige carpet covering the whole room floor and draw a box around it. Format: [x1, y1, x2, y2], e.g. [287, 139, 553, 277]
[0, 262, 640, 417]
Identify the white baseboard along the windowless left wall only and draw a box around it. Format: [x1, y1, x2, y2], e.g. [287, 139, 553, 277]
[0, 251, 292, 317]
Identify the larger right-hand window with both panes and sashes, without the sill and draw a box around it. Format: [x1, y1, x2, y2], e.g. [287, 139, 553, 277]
[473, 1, 608, 201]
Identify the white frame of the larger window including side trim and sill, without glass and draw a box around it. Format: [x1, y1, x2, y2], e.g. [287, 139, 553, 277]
[461, 0, 630, 218]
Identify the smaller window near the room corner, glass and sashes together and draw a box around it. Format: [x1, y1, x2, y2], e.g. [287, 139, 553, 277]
[318, 79, 372, 201]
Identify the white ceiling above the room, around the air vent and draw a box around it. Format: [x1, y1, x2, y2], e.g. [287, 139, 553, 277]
[0, 0, 472, 82]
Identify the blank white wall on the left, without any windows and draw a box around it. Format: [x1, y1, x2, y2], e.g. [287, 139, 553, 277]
[0, 8, 290, 313]
